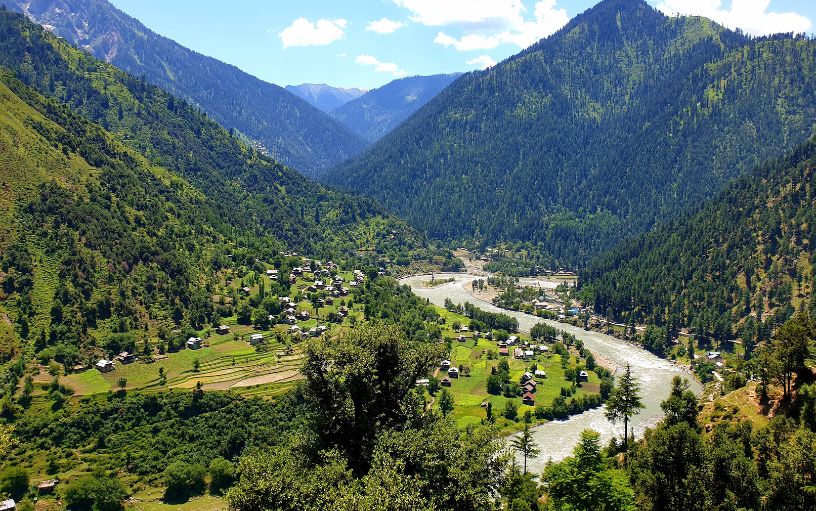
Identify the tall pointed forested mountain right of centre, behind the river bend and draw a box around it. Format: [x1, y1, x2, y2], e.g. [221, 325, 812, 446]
[326, 0, 816, 266]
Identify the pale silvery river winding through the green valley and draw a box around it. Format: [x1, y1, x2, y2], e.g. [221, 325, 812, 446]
[401, 273, 702, 473]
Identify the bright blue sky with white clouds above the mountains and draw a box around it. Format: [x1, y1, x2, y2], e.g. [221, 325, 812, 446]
[110, 0, 816, 89]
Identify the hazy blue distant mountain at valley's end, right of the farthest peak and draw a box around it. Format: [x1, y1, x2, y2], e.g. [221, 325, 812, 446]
[332, 73, 461, 142]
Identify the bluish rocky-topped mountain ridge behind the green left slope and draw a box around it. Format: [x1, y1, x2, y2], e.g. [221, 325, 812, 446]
[5, 0, 365, 175]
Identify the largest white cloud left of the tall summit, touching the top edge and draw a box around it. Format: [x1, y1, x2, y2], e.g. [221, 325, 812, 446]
[394, 0, 569, 51]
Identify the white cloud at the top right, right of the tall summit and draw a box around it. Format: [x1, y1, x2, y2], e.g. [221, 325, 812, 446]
[657, 0, 813, 35]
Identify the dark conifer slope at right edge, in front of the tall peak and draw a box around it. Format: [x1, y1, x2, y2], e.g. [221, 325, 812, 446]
[584, 139, 816, 345]
